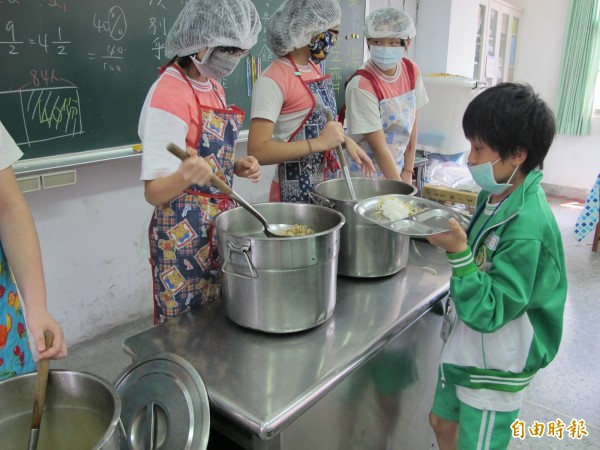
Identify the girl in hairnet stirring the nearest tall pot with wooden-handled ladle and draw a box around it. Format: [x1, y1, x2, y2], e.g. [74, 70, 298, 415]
[138, 0, 261, 323]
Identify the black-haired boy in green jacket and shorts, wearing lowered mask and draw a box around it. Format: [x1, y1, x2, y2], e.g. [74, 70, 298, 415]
[429, 83, 567, 450]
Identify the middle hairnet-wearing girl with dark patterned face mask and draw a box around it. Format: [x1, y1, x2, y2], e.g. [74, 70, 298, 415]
[248, 0, 374, 203]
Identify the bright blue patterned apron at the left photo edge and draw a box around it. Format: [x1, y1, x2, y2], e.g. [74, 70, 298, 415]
[0, 244, 35, 380]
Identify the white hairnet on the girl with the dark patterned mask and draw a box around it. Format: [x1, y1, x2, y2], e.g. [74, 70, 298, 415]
[266, 0, 342, 56]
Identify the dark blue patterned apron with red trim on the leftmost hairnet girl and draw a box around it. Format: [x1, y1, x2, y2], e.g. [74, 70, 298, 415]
[149, 66, 245, 323]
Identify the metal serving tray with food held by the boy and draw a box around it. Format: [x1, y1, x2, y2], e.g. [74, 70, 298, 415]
[354, 194, 465, 237]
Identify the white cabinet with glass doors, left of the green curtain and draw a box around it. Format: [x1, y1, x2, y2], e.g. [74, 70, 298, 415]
[473, 0, 522, 86]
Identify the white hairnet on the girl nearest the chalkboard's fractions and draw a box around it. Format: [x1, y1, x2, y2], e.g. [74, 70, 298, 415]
[165, 0, 261, 58]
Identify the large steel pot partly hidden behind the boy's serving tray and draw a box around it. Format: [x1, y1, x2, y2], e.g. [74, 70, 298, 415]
[311, 178, 417, 278]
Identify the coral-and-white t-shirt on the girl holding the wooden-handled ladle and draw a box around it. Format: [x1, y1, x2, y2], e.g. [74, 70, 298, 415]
[138, 67, 226, 180]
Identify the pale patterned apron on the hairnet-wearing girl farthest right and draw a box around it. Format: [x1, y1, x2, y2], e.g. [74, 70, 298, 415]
[348, 89, 417, 178]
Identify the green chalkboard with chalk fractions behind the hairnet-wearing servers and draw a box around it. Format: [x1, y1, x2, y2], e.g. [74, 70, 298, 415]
[0, 0, 365, 159]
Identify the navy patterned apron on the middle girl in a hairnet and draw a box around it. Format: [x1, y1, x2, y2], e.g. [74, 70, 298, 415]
[270, 56, 340, 203]
